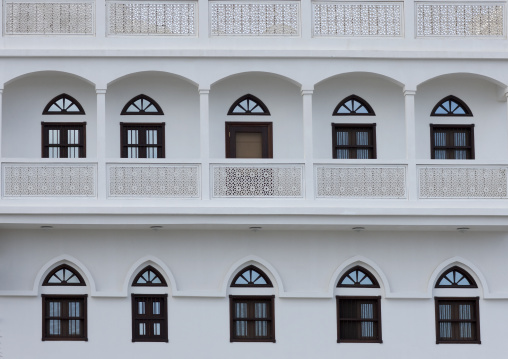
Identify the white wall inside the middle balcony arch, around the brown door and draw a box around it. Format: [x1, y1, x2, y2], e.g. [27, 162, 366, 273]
[210, 73, 303, 160]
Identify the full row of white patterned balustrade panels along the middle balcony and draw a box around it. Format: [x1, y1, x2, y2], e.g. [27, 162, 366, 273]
[2, 160, 508, 203]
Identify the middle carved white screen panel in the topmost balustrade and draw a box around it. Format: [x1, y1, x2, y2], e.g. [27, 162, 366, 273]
[210, 1, 300, 36]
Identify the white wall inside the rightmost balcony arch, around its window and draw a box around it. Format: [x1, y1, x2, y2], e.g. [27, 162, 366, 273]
[415, 74, 508, 161]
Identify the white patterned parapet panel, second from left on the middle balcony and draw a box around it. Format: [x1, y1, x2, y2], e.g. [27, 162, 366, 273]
[107, 164, 201, 198]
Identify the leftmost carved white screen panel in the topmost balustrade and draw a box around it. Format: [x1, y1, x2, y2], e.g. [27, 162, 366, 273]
[4, 2, 95, 35]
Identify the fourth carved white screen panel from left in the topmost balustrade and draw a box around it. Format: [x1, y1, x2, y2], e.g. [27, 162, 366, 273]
[312, 2, 402, 37]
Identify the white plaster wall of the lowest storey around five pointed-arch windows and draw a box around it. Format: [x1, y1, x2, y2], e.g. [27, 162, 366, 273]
[0, 230, 508, 359]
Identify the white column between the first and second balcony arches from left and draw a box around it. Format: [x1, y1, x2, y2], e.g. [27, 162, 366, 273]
[95, 89, 107, 200]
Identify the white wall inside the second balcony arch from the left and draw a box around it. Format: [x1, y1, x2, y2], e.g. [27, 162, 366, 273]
[106, 72, 199, 159]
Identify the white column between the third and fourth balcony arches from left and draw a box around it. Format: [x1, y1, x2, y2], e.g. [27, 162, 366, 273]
[302, 87, 314, 200]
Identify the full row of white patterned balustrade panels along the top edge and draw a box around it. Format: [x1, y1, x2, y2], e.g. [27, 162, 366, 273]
[4, 0, 506, 38]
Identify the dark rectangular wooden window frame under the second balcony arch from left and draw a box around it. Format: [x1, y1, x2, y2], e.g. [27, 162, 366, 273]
[120, 122, 166, 159]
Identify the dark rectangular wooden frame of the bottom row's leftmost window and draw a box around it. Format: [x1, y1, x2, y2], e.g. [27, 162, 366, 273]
[41, 294, 88, 341]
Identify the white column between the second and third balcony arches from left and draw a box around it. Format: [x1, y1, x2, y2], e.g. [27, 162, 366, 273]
[199, 87, 210, 200]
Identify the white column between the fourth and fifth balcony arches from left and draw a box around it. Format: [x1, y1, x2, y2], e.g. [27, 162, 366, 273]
[404, 88, 418, 201]
